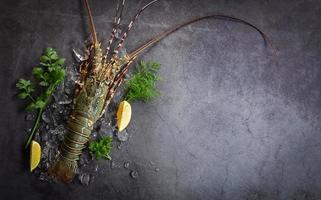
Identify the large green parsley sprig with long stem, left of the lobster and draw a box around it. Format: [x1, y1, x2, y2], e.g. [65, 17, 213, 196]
[16, 48, 65, 148]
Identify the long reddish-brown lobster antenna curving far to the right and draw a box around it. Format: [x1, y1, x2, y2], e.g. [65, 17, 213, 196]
[128, 14, 269, 58]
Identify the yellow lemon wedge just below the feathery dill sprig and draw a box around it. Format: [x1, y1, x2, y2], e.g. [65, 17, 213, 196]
[117, 101, 132, 132]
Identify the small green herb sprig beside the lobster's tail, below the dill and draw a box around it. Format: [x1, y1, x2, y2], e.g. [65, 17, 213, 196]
[89, 136, 113, 160]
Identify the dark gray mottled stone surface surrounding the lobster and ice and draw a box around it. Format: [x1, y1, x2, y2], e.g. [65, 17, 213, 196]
[0, 0, 321, 200]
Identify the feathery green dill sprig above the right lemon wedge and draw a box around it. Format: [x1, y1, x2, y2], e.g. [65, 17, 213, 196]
[125, 61, 160, 102]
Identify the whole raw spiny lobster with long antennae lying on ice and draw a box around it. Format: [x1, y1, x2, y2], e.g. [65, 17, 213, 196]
[49, 0, 266, 183]
